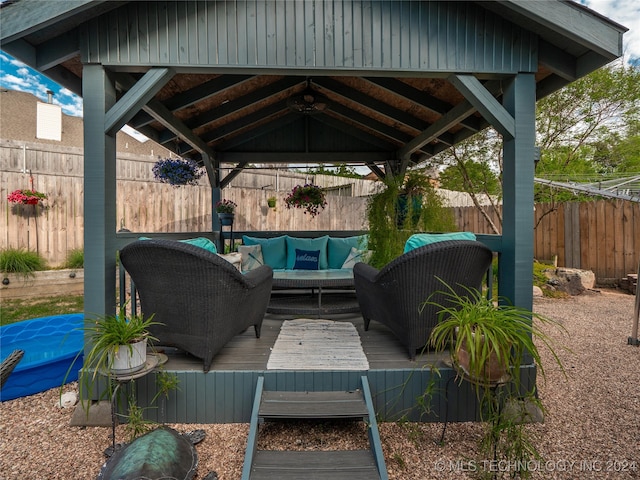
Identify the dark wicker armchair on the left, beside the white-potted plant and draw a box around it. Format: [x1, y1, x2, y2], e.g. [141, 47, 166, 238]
[120, 239, 273, 372]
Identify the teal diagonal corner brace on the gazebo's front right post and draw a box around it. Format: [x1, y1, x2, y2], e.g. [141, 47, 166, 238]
[449, 75, 515, 139]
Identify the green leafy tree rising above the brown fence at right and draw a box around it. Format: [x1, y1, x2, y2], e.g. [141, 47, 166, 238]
[432, 62, 640, 210]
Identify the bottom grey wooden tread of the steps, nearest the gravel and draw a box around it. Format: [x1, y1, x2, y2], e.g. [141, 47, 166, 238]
[251, 450, 380, 480]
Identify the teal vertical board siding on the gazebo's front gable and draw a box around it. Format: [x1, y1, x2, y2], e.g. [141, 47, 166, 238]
[82, 0, 538, 74]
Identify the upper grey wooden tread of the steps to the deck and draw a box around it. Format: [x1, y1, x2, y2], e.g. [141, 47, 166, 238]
[258, 390, 369, 419]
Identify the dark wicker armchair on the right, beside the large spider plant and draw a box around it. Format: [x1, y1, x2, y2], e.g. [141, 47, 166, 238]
[353, 240, 493, 360]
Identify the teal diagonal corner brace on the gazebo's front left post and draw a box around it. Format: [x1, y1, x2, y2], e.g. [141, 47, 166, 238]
[104, 67, 175, 135]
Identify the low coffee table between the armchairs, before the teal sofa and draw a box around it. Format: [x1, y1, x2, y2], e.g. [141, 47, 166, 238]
[267, 269, 360, 315]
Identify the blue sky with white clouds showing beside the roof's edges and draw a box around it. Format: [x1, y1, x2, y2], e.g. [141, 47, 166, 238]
[0, 0, 640, 123]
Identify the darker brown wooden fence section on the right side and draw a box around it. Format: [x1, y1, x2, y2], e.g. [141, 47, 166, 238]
[454, 200, 640, 283]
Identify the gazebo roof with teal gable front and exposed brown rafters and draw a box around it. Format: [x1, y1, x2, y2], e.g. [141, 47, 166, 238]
[0, 0, 626, 180]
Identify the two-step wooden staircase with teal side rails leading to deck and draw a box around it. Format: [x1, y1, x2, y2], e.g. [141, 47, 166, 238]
[242, 376, 389, 480]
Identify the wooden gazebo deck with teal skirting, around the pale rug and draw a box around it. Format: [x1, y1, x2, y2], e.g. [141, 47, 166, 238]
[129, 314, 535, 423]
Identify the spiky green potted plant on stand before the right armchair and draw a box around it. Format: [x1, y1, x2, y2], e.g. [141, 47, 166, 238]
[425, 282, 564, 478]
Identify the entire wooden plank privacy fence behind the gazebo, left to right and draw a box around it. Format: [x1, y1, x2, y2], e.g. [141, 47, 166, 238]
[0, 140, 640, 282]
